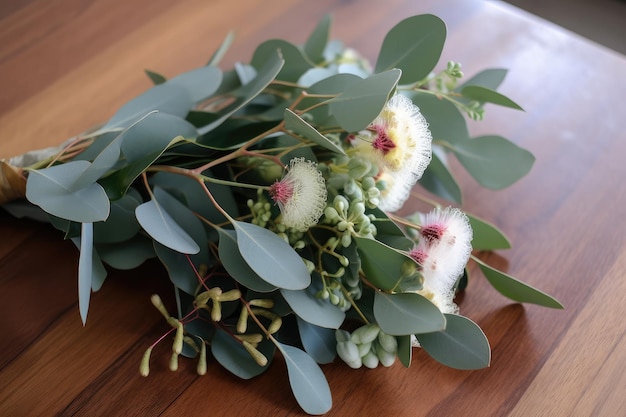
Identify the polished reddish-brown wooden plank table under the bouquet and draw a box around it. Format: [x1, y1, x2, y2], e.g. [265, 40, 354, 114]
[0, 0, 626, 416]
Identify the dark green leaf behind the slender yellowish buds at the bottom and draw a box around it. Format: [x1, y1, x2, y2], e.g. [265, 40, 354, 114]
[211, 328, 274, 379]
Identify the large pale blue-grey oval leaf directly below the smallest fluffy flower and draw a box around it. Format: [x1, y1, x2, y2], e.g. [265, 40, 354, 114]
[231, 220, 311, 290]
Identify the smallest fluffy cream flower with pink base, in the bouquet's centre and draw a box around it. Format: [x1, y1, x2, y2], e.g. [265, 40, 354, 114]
[269, 158, 327, 231]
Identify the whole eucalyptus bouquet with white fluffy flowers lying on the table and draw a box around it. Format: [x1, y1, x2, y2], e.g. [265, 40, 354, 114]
[0, 15, 561, 414]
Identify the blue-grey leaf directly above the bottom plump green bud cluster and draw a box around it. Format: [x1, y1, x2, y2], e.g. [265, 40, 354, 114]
[280, 276, 346, 329]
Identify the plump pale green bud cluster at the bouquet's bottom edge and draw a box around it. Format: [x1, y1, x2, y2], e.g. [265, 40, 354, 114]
[335, 324, 398, 369]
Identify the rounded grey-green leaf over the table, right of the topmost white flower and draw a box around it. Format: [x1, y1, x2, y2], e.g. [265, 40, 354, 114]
[452, 136, 535, 190]
